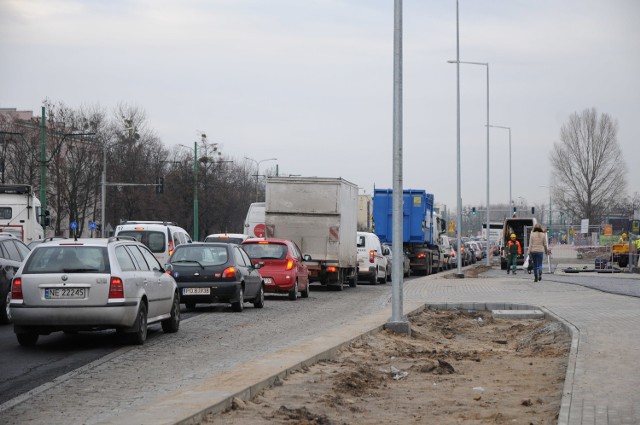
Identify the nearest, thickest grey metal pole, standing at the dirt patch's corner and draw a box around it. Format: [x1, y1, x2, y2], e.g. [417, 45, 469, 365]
[385, 0, 411, 334]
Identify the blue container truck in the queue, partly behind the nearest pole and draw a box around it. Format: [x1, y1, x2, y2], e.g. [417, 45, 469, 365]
[373, 189, 441, 275]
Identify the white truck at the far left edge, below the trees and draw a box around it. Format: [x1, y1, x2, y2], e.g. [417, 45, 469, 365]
[0, 184, 44, 244]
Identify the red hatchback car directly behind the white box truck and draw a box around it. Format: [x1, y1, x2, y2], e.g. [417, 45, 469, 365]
[242, 238, 309, 301]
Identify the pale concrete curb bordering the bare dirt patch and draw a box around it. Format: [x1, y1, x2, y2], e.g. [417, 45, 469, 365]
[110, 302, 579, 425]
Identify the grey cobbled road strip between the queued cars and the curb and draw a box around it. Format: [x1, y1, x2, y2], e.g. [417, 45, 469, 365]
[0, 278, 398, 424]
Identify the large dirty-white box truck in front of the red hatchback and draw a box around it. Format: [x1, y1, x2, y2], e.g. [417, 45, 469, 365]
[265, 177, 358, 290]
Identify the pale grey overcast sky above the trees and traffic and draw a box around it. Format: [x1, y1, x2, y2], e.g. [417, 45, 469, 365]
[0, 0, 640, 210]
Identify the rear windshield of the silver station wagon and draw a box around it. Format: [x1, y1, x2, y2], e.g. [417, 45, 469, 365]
[22, 245, 111, 274]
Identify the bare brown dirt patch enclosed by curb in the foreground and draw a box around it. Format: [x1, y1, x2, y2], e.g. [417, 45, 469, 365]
[203, 310, 571, 425]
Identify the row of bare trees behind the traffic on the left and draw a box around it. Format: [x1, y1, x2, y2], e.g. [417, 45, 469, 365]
[0, 101, 272, 236]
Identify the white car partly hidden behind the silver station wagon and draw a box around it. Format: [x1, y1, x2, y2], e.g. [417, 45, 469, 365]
[114, 221, 192, 266]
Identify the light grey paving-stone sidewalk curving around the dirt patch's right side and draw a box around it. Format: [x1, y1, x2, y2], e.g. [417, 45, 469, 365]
[404, 270, 640, 425]
